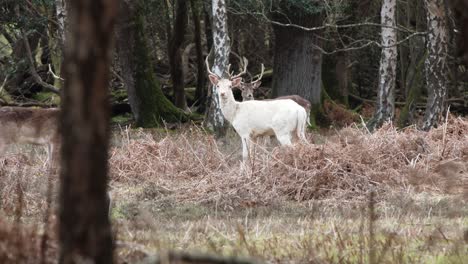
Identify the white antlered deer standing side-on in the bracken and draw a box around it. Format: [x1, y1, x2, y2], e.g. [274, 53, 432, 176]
[205, 60, 307, 161]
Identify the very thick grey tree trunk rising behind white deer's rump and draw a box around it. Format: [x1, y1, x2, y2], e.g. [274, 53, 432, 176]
[273, 19, 322, 123]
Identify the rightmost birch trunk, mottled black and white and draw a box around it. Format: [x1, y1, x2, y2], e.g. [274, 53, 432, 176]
[422, 0, 449, 130]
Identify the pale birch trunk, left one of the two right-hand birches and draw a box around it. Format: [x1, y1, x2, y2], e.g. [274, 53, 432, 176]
[368, 0, 398, 131]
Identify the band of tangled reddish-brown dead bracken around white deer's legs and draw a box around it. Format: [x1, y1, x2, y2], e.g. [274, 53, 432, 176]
[110, 117, 468, 208]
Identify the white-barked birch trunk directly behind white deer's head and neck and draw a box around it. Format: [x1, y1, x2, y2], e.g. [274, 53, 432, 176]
[206, 0, 230, 137]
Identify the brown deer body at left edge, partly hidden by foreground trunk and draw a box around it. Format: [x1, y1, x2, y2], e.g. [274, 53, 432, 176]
[0, 107, 59, 165]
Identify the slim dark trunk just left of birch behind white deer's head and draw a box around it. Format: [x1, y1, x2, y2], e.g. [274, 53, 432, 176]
[190, 0, 209, 113]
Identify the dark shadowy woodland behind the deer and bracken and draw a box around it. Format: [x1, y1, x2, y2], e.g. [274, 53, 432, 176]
[0, 0, 468, 129]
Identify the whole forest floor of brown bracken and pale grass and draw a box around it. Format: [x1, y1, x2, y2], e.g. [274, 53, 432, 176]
[0, 117, 468, 263]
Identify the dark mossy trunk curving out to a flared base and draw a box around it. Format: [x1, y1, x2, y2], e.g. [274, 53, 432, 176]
[116, 0, 187, 127]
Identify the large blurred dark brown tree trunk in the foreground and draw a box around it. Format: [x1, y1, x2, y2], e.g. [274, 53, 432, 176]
[59, 0, 117, 263]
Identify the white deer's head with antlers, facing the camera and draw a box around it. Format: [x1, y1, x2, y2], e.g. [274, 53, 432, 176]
[205, 56, 248, 100]
